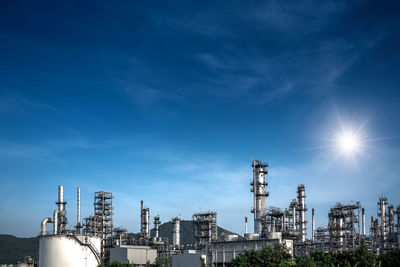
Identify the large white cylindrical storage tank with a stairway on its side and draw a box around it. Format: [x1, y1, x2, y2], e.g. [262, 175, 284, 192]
[39, 235, 101, 267]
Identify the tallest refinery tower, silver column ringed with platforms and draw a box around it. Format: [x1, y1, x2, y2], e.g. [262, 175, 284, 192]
[250, 160, 269, 234]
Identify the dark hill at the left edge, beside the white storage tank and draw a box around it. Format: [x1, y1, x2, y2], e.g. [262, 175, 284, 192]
[0, 235, 39, 264]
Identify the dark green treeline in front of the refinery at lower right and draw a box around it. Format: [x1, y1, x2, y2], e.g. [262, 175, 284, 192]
[229, 244, 400, 267]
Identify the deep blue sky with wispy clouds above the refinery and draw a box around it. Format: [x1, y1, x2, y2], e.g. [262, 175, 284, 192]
[0, 0, 400, 239]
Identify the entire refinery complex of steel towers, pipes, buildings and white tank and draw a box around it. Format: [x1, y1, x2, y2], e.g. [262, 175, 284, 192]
[39, 160, 400, 267]
